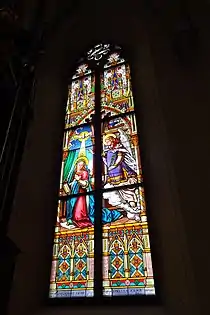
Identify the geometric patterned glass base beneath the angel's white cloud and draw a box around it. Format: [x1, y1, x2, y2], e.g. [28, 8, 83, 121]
[103, 219, 155, 296]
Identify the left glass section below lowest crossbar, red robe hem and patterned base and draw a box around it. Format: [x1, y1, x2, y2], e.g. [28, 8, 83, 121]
[50, 199, 94, 298]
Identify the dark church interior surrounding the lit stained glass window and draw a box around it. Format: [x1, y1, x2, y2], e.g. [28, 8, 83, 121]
[0, 0, 210, 315]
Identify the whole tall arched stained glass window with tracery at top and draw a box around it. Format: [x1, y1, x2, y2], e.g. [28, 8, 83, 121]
[50, 44, 155, 299]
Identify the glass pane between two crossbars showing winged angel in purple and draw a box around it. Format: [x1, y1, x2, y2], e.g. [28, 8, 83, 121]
[102, 113, 142, 189]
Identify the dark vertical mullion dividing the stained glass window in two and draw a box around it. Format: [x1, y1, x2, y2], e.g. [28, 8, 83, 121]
[94, 67, 102, 298]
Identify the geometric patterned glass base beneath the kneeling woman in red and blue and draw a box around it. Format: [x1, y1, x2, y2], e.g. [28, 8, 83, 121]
[50, 226, 93, 298]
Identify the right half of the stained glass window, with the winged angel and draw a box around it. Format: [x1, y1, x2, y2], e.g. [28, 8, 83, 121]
[101, 55, 155, 296]
